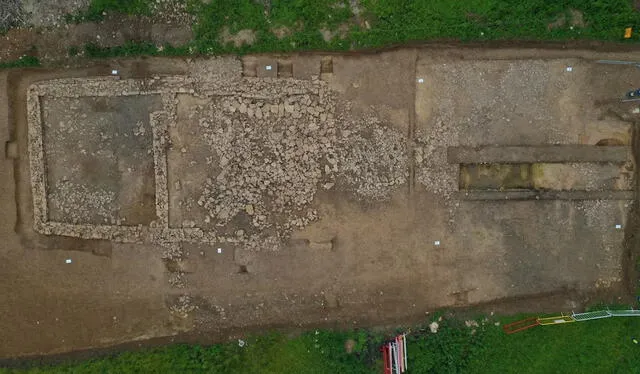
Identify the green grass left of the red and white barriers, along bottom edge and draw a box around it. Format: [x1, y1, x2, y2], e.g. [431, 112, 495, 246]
[6, 331, 377, 374]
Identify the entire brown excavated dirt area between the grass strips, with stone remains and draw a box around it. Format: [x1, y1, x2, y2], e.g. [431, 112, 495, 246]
[0, 47, 640, 358]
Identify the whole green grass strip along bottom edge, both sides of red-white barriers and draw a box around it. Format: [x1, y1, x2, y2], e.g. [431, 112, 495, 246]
[8, 316, 640, 374]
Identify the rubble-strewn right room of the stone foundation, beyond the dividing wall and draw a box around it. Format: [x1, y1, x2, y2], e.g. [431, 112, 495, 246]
[166, 80, 335, 240]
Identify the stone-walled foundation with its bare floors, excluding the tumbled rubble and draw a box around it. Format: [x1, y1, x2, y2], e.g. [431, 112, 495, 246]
[27, 74, 323, 246]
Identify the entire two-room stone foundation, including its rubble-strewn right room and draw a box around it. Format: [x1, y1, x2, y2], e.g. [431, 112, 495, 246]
[28, 76, 328, 242]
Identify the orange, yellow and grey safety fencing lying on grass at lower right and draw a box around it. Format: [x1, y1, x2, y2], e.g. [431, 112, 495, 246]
[502, 309, 640, 334]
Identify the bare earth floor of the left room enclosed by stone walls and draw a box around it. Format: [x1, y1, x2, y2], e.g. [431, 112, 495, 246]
[41, 95, 161, 225]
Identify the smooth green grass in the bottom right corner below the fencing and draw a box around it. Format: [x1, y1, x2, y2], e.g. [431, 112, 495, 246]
[469, 317, 640, 374]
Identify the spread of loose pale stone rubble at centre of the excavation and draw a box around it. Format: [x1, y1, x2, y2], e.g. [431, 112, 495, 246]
[191, 80, 407, 247]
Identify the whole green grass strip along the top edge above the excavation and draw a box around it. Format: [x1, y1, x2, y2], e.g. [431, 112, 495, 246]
[58, 0, 640, 57]
